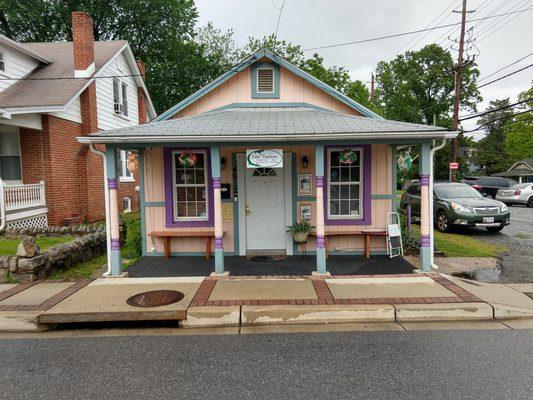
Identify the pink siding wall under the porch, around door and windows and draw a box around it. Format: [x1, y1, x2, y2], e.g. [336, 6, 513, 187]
[144, 144, 394, 254]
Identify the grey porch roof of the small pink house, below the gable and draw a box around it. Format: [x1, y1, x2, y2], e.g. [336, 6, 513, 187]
[78, 103, 457, 143]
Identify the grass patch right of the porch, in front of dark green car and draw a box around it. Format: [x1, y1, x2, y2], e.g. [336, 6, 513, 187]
[411, 225, 507, 257]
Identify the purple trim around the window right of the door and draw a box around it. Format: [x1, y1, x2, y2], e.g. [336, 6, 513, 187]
[324, 144, 372, 225]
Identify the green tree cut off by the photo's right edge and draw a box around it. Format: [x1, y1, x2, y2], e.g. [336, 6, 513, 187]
[504, 87, 533, 163]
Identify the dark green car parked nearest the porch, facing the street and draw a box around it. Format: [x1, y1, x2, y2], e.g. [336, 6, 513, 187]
[400, 181, 510, 232]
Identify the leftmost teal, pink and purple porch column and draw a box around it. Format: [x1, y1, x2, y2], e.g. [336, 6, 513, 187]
[105, 146, 122, 276]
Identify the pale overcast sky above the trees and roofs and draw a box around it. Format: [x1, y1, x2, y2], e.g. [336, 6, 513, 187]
[196, 0, 533, 134]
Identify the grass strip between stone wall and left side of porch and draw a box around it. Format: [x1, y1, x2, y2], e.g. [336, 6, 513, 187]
[50, 212, 141, 279]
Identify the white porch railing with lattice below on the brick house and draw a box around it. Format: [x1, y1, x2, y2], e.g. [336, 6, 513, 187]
[0, 180, 48, 230]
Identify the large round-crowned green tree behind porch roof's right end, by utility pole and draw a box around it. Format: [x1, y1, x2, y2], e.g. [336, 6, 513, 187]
[376, 44, 481, 126]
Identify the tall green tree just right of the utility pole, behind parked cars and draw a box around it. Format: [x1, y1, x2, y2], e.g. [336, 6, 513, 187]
[474, 98, 514, 175]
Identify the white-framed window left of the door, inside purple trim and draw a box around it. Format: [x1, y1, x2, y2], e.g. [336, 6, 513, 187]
[172, 150, 210, 221]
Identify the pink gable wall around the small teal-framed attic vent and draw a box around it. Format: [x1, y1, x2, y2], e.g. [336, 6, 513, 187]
[171, 67, 361, 118]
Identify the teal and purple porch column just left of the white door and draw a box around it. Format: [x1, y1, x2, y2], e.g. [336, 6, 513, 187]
[211, 146, 224, 274]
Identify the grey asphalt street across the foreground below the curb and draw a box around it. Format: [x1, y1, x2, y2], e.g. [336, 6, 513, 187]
[0, 330, 533, 400]
